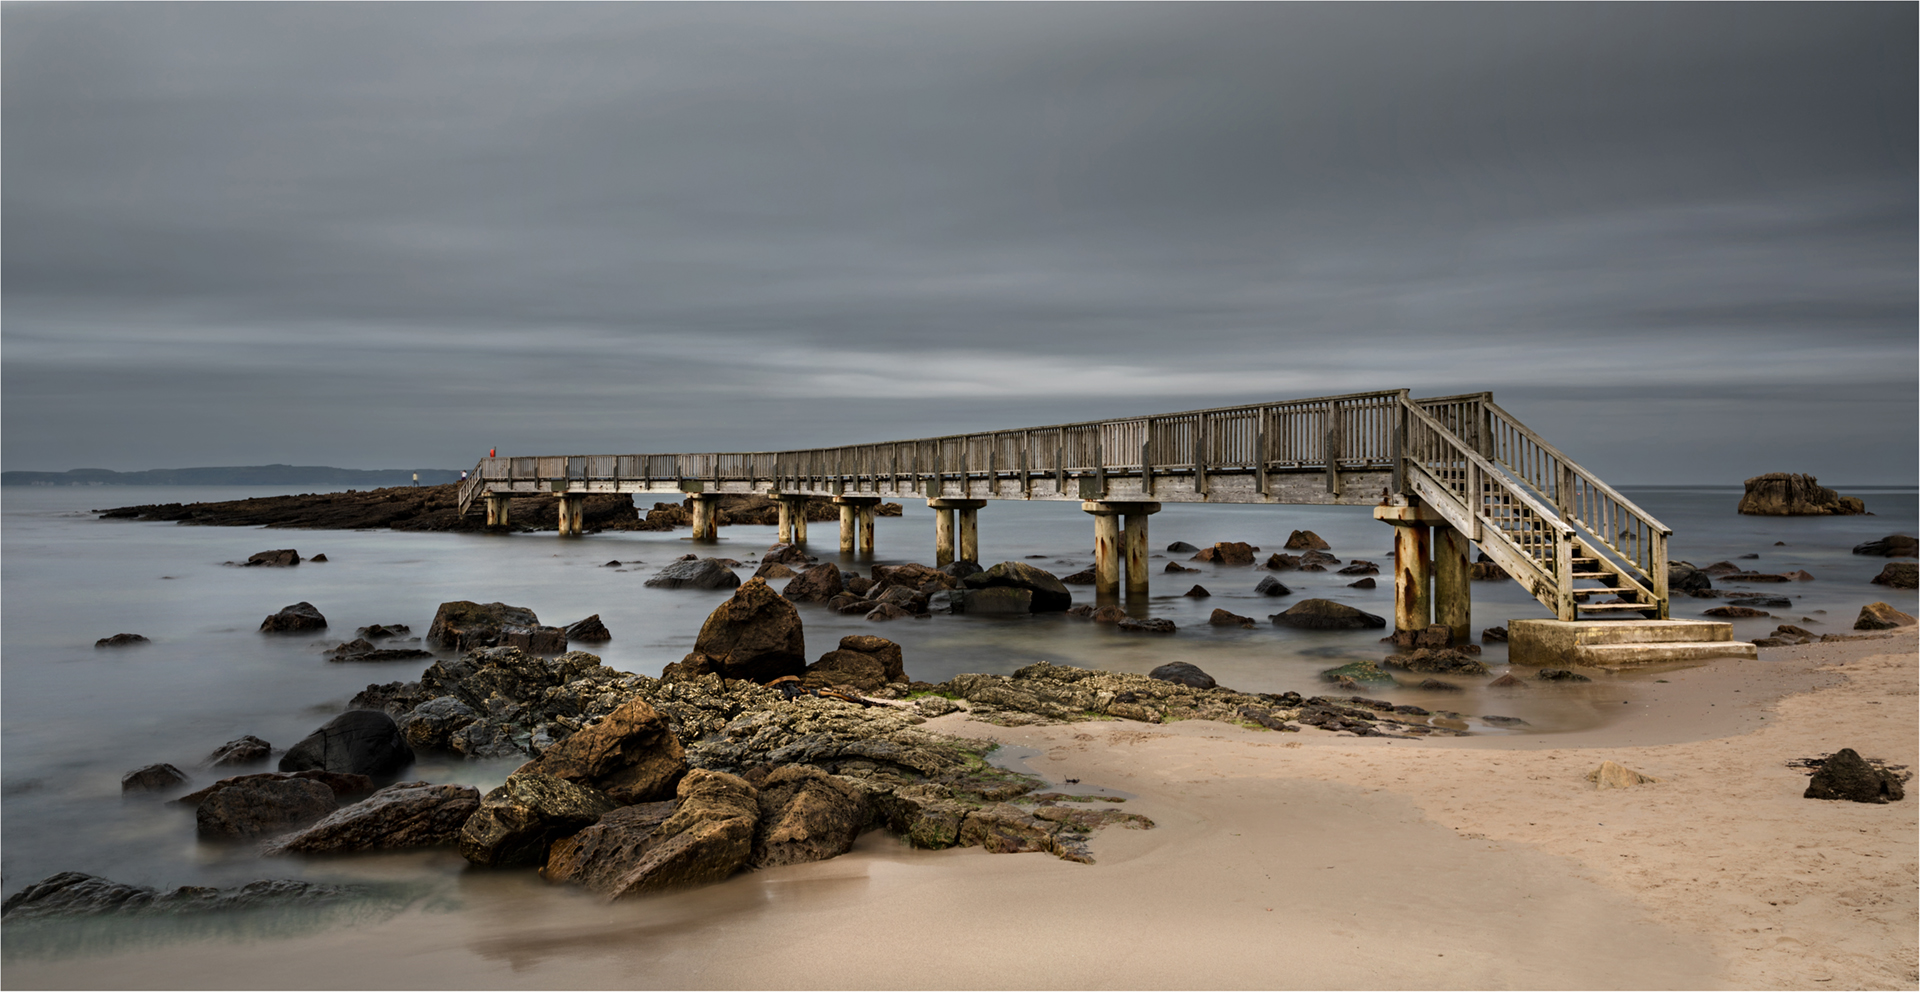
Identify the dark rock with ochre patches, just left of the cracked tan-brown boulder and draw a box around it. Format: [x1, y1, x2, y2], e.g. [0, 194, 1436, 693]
[455, 771, 620, 867]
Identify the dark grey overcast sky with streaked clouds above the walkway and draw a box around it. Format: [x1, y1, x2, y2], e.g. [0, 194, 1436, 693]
[0, 4, 1920, 484]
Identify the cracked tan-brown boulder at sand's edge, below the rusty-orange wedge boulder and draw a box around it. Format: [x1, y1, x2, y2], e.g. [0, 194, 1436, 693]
[541, 769, 760, 900]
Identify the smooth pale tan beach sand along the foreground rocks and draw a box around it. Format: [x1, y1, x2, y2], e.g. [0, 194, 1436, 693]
[6, 629, 1920, 988]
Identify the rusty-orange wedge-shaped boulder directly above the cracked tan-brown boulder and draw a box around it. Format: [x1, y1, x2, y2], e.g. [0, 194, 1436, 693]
[518, 698, 687, 806]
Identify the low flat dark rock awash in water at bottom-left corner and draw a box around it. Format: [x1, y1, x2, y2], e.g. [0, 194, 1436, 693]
[0, 871, 363, 923]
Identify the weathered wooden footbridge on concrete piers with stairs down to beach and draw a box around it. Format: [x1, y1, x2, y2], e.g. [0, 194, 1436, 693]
[461, 390, 1672, 626]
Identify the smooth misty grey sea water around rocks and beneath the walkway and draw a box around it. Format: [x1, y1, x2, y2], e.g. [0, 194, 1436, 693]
[0, 479, 1916, 902]
